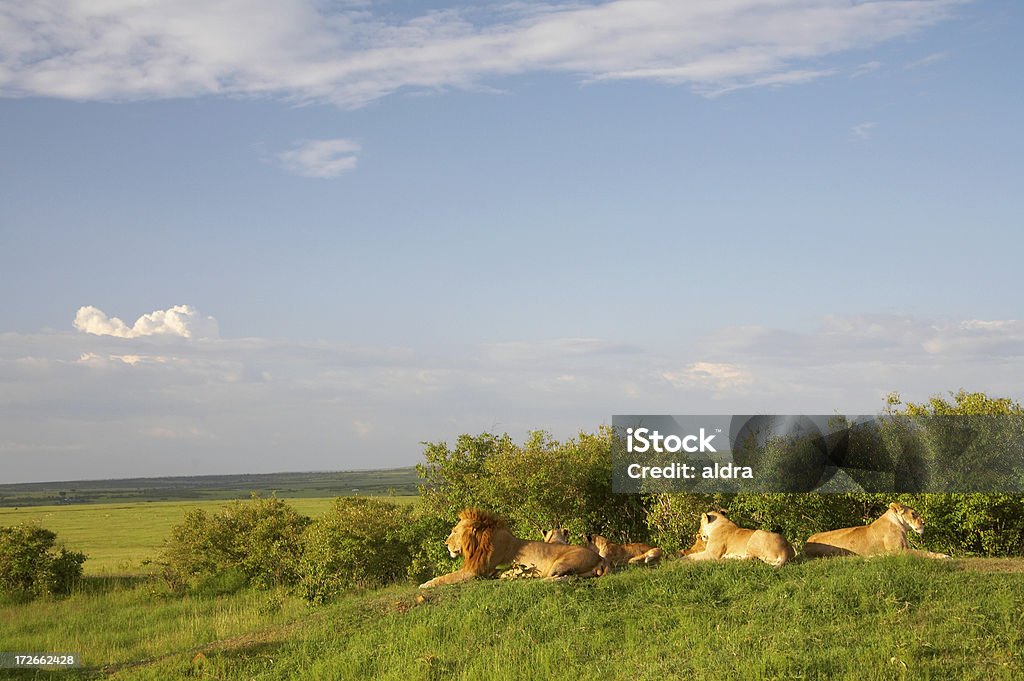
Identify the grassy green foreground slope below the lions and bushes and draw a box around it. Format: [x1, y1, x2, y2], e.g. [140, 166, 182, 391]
[0, 556, 1024, 681]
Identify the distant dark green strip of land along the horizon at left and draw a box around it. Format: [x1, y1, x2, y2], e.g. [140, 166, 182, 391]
[0, 467, 419, 507]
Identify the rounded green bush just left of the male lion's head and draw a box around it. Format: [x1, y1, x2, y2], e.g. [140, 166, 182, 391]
[300, 497, 421, 603]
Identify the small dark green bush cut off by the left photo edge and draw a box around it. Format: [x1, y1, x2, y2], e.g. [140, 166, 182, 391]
[0, 525, 85, 597]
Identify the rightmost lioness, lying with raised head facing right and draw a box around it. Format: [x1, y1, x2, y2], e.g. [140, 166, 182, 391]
[804, 504, 949, 558]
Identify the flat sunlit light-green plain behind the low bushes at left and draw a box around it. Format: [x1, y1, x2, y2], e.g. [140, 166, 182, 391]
[0, 497, 418, 576]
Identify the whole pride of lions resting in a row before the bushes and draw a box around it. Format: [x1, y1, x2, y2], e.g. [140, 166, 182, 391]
[420, 504, 949, 589]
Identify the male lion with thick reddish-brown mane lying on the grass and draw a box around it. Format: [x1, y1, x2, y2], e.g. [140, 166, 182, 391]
[420, 508, 607, 589]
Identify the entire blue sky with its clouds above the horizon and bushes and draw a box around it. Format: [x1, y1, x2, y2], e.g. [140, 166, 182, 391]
[0, 0, 1024, 481]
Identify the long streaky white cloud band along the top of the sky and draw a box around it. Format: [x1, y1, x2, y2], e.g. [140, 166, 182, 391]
[0, 0, 959, 108]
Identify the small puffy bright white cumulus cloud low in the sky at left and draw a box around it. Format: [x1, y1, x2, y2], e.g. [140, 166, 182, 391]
[75, 305, 218, 337]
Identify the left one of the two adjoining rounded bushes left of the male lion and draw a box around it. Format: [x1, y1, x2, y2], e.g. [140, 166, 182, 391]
[162, 495, 311, 588]
